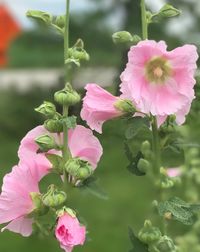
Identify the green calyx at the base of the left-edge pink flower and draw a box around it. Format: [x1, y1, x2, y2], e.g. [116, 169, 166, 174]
[30, 192, 49, 216]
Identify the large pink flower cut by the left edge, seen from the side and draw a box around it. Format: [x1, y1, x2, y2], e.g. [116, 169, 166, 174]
[0, 159, 44, 236]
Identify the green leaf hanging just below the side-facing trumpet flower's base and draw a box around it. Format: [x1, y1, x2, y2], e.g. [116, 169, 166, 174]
[125, 116, 149, 140]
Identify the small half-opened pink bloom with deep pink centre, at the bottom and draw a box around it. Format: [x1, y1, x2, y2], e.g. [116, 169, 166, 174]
[55, 212, 86, 252]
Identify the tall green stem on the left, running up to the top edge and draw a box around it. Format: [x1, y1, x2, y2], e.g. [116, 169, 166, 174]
[63, 0, 70, 161]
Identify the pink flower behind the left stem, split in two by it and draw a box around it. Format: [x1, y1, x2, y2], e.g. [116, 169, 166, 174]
[18, 125, 103, 169]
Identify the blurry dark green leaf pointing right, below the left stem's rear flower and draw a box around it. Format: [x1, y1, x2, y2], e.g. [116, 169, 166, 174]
[78, 176, 108, 200]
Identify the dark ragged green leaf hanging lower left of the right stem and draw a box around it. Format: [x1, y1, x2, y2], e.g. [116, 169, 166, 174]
[124, 142, 146, 176]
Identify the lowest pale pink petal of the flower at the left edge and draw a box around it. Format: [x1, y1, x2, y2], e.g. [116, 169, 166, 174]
[1, 217, 33, 237]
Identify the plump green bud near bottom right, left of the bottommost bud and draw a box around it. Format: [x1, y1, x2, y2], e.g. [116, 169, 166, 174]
[138, 220, 161, 244]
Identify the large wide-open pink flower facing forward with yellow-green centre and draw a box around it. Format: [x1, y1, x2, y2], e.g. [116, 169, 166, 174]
[121, 40, 198, 124]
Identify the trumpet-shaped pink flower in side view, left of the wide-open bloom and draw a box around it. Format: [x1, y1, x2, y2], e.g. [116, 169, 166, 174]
[81, 84, 123, 133]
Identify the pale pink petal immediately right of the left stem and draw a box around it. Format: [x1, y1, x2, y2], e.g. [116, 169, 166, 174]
[68, 125, 103, 169]
